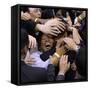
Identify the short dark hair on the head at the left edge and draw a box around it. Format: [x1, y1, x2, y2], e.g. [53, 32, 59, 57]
[20, 29, 29, 49]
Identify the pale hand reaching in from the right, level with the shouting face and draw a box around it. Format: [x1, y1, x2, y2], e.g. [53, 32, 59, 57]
[63, 37, 78, 51]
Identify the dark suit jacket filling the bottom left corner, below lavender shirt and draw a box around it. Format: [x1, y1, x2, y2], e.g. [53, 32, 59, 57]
[21, 61, 47, 83]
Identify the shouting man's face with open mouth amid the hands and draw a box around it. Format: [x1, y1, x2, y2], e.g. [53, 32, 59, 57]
[41, 34, 54, 52]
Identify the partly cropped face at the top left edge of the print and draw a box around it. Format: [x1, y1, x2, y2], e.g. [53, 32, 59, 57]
[29, 8, 41, 18]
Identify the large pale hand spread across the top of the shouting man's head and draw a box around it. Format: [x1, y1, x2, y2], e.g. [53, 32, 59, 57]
[36, 18, 65, 36]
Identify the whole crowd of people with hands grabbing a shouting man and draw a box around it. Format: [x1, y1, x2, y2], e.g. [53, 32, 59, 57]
[20, 6, 87, 83]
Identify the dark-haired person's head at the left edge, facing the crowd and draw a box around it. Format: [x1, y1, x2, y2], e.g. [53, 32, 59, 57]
[20, 29, 29, 59]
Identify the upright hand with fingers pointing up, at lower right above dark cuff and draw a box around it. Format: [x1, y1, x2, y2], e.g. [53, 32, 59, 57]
[59, 55, 70, 75]
